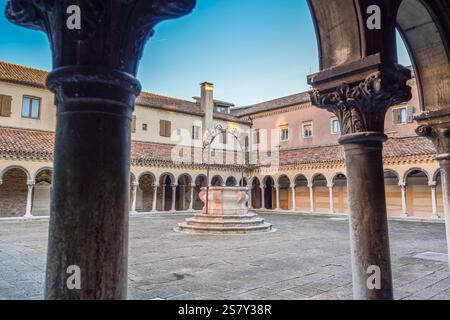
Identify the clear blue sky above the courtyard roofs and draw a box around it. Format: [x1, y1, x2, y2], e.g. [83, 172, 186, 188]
[0, 0, 409, 106]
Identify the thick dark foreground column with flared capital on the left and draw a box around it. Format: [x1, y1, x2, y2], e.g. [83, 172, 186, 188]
[6, 0, 195, 299]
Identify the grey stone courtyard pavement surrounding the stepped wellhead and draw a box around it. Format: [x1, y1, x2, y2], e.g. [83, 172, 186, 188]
[0, 214, 450, 300]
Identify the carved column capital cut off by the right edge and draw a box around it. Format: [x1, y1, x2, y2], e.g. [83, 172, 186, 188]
[415, 108, 450, 160]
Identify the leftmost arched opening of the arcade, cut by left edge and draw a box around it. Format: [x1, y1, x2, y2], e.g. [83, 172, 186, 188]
[0, 168, 28, 217]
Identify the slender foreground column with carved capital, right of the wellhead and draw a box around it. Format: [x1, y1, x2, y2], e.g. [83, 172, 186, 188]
[310, 67, 411, 300]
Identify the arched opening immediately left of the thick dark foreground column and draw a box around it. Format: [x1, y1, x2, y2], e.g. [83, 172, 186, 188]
[31, 169, 52, 216]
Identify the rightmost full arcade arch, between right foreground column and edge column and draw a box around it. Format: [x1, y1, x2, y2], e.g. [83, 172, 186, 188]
[405, 169, 433, 218]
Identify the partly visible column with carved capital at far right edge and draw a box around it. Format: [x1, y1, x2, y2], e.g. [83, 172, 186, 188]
[416, 108, 450, 272]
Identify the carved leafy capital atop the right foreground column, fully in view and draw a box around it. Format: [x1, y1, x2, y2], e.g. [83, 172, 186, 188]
[310, 69, 412, 143]
